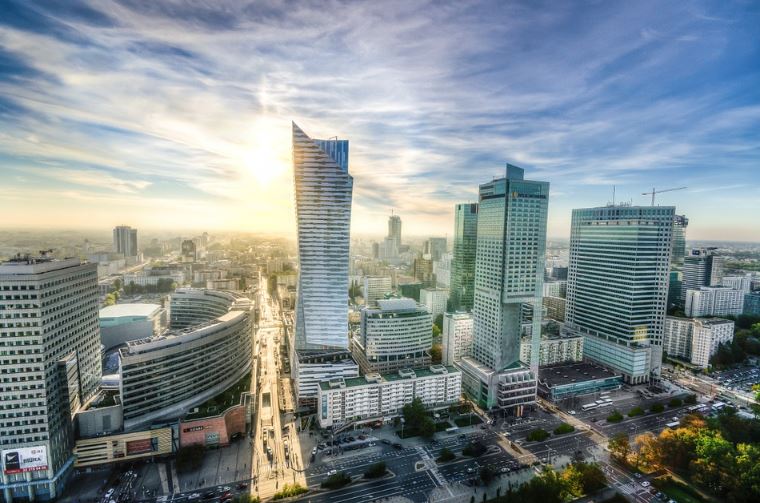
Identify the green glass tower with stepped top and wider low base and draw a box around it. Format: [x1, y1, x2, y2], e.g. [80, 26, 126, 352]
[460, 164, 549, 414]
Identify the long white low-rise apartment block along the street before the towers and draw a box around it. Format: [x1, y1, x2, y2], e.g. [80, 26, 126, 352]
[317, 365, 462, 428]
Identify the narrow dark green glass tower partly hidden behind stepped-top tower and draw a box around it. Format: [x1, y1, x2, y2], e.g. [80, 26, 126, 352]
[449, 203, 478, 311]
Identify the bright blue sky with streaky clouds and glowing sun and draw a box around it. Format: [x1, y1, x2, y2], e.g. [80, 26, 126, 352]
[0, 0, 760, 241]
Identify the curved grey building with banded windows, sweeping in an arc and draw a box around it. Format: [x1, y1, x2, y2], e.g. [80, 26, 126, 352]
[120, 289, 253, 430]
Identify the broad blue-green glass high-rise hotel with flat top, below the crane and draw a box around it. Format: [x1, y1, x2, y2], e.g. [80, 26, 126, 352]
[565, 206, 675, 384]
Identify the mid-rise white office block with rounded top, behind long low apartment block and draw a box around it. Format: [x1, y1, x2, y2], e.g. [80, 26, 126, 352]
[352, 298, 433, 373]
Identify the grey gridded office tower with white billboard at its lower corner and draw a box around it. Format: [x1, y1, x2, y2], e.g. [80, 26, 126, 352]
[0, 256, 101, 501]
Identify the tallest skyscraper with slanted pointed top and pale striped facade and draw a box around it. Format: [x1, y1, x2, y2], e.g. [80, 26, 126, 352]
[291, 123, 358, 404]
